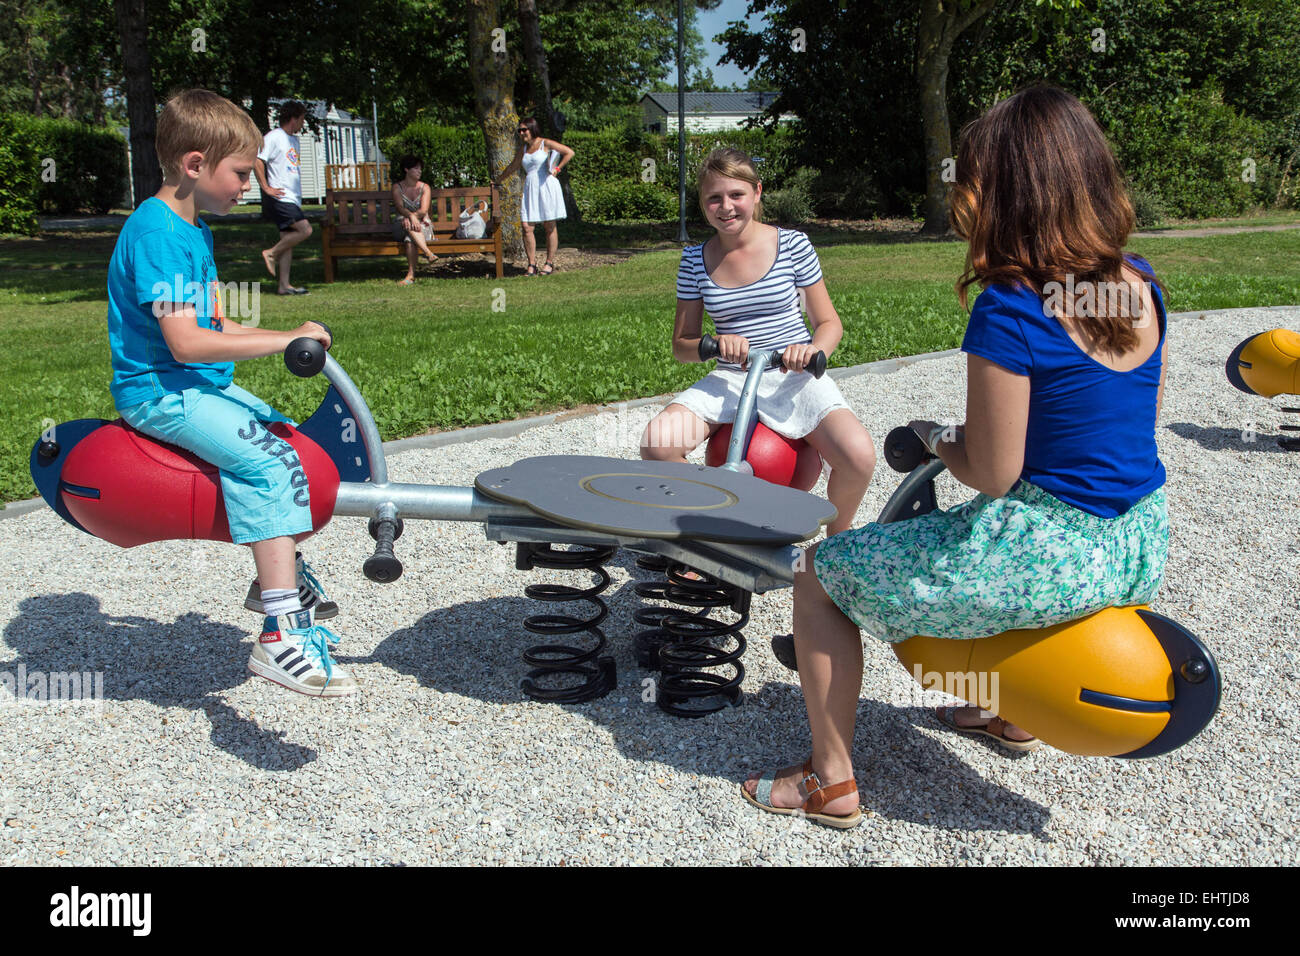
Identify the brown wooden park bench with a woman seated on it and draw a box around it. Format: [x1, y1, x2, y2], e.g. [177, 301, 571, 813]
[321, 186, 504, 282]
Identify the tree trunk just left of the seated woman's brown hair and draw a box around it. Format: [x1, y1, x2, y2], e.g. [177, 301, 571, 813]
[917, 0, 995, 235]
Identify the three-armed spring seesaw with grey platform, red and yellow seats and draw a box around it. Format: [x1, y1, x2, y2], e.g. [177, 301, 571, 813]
[31, 338, 1218, 757]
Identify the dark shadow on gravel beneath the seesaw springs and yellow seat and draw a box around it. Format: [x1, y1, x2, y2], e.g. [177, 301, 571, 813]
[361, 551, 1050, 836]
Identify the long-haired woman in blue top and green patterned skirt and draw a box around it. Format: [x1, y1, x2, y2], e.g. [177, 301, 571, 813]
[742, 86, 1169, 827]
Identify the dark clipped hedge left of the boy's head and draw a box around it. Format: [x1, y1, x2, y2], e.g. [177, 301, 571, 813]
[13, 116, 127, 216]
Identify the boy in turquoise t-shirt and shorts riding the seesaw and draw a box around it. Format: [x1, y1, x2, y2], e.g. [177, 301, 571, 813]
[108, 90, 358, 697]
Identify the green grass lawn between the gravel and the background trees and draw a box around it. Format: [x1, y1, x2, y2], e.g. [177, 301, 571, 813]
[0, 224, 1300, 501]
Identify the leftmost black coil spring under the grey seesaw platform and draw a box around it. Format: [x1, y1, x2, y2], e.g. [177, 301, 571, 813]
[515, 542, 618, 704]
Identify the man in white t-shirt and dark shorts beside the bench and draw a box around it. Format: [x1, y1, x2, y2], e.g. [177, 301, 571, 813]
[254, 100, 312, 295]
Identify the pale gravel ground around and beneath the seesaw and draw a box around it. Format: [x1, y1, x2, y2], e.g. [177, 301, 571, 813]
[0, 308, 1300, 865]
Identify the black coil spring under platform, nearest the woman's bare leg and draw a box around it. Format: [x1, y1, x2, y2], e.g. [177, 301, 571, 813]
[632, 558, 751, 717]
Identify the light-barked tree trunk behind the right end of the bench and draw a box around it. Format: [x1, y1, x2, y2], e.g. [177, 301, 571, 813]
[465, 0, 524, 260]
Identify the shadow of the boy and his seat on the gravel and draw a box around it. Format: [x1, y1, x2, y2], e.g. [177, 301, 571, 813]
[3, 593, 317, 770]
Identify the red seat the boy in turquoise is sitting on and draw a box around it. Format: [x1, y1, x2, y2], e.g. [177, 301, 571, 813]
[60, 419, 339, 548]
